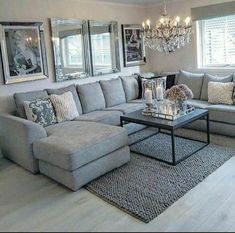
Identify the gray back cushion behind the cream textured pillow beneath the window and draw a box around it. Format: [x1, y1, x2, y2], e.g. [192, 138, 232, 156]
[201, 74, 233, 101]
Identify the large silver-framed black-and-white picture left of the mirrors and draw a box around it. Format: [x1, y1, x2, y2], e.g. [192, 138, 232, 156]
[0, 22, 48, 84]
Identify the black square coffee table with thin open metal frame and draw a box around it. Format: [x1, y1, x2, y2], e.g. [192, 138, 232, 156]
[120, 109, 210, 166]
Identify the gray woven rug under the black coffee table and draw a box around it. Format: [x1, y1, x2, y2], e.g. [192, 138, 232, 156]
[87, 131, 235, 223]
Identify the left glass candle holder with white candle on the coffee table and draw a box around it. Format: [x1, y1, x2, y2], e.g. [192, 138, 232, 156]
[142, 79, 156, 116]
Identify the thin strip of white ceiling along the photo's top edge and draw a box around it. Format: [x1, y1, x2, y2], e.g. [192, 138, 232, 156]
[85, 0, 173, 6]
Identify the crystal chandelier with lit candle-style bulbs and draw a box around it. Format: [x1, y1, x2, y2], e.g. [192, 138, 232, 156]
[143, 0, 192, 54]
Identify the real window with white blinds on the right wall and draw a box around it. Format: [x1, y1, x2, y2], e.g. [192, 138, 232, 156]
[198, 15, 235, 68]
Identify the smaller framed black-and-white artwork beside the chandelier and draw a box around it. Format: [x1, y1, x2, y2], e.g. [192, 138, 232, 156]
[122, 24, 146, 67]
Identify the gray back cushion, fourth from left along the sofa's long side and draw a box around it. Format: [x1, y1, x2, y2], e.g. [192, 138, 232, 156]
[100, 78, 126, 107]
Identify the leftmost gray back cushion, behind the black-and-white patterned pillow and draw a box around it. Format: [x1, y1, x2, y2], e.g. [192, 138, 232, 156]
[14, 91, 48, 119]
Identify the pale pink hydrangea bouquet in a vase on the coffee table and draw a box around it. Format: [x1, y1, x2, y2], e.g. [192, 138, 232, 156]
[166, 84, 193, 115]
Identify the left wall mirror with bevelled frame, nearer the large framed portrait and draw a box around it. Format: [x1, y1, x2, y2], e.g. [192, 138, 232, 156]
[51, 18, 91, 82]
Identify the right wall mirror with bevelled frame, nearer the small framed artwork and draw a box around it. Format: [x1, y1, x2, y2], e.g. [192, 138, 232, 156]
[88, 20, 120, 76]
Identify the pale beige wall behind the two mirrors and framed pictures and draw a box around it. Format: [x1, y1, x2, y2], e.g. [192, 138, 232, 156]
[0, 0, 148, 112]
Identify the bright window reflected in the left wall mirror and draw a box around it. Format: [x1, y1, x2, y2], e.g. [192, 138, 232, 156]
[62, 35, 83, 69]
